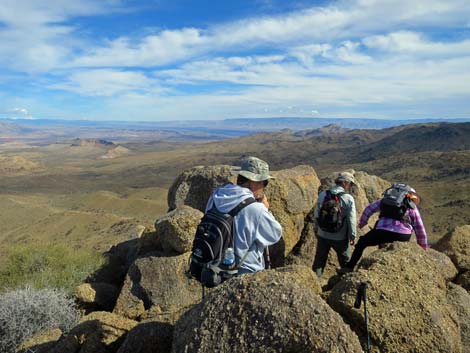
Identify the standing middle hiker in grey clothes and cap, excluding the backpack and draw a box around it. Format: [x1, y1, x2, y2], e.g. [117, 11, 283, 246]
[312, 172, 357, 277]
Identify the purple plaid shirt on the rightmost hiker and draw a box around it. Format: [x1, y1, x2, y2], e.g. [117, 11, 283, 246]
[359, 200, 429, 250]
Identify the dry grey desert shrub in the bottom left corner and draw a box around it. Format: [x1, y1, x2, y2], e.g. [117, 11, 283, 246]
[0, 287, 79, 353]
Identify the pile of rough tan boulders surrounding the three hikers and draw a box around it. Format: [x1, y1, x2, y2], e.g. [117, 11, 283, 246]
[23, 165, 470, 353]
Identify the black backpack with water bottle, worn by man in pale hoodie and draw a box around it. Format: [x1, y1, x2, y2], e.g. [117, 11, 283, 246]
[189, 197, 256, 288]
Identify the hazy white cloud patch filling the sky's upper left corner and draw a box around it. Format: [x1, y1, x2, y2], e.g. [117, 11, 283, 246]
[0, 0, 123, 72]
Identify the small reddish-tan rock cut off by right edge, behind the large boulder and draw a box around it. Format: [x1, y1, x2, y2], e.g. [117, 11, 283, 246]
[434, 225, 470, 272]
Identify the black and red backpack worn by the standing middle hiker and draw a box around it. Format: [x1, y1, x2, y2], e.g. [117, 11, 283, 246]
[317, 190, 344, 233]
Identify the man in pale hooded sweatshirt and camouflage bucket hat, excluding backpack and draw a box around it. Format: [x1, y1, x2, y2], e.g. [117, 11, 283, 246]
[206, 157, 282, 274]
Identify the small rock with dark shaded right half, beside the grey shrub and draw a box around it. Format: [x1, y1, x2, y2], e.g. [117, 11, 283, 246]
[73, 283, 119, 310]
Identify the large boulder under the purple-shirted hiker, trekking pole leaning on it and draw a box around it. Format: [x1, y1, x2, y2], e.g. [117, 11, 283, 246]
[328, 242, 462, 353]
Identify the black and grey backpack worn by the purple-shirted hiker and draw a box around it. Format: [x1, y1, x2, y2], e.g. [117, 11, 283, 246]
[380, 183, 415, 222]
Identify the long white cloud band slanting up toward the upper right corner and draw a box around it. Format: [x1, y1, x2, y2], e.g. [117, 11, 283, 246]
[62, 0, 470, 67]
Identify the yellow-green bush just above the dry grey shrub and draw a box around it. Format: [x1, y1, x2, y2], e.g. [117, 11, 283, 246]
[0, 244, 104, 293]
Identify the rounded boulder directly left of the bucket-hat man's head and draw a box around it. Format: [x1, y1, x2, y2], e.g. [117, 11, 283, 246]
[168, 165, 236, 212]
